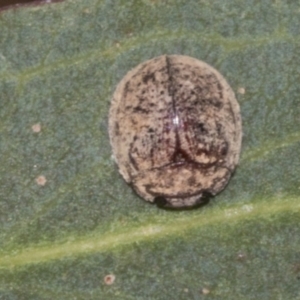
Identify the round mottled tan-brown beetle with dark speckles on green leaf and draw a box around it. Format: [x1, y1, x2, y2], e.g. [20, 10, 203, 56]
[109, 55, 242, 207]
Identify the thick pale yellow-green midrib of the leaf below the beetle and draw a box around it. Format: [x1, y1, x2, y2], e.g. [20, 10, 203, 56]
[0, 197, 300, 269]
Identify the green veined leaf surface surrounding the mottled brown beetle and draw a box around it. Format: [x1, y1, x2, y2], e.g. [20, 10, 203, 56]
[0, 0, 300, 300]
